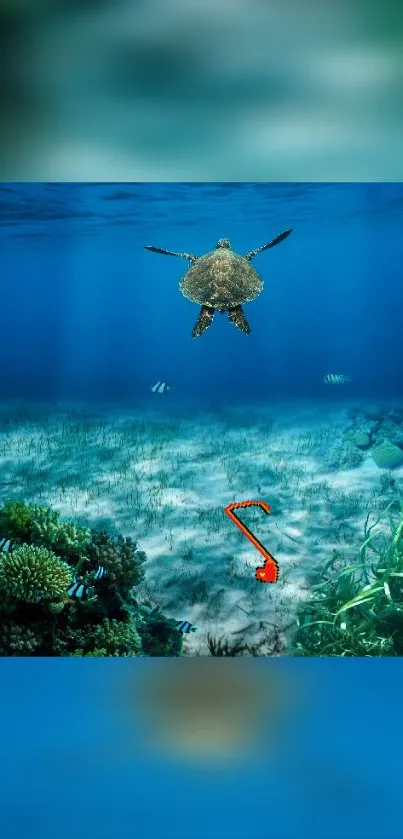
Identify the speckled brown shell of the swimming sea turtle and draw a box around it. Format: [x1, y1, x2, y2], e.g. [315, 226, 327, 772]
[179, 248, 263, 312]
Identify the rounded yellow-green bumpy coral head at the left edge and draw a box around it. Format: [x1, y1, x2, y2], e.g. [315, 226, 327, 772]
[0, 544, 73, 603]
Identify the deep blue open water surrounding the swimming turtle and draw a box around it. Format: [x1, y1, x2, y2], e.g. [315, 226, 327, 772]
[0, 183, 403, 403]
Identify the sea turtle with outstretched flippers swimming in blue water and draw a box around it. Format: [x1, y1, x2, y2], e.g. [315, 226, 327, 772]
[144, 230, 292, 338]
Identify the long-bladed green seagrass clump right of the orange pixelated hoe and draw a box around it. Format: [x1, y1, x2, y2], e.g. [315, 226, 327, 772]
[292, 501, 403, 656]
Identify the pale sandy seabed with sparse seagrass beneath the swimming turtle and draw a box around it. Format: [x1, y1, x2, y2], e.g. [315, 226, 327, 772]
[0, 396, 403, 655]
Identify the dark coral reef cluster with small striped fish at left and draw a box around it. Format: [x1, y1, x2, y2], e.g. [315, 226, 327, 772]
[0, 500, 183, 656]
